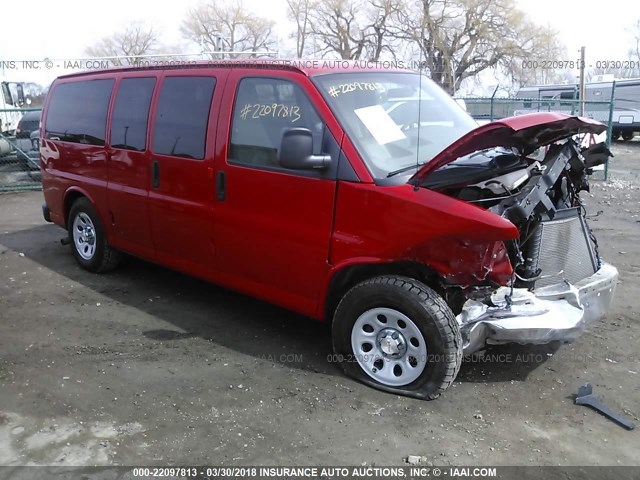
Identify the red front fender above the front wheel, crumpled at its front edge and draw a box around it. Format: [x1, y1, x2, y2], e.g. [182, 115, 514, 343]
[319, 182, 519, 316]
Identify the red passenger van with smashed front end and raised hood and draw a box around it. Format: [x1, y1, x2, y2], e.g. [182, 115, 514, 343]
[40, 61, 617, 399]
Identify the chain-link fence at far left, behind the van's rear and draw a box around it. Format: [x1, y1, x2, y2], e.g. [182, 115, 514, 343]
[0, 108, 42, 192]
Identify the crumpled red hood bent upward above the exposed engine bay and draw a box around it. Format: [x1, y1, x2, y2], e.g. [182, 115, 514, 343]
[409, 112, 607, 185]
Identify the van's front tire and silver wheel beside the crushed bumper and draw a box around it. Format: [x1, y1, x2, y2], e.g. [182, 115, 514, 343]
[332, 276, 462, 400]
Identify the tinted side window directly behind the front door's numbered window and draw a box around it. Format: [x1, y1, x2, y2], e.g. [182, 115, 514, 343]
[152, 77, 216, 159]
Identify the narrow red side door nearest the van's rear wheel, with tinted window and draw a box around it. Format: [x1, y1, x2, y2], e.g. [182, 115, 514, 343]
[107, 72, 157, 258]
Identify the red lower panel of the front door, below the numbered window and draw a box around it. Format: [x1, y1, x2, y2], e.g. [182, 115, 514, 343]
[215, 165, 335, 315]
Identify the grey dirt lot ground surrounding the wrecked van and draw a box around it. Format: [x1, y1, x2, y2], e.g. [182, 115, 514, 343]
[0, 142, 640, 465]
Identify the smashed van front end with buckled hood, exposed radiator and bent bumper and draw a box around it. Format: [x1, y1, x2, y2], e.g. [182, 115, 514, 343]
[409, 113, 618, 353]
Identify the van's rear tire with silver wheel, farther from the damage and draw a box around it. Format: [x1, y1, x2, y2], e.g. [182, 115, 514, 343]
[67, 198, 121, 272]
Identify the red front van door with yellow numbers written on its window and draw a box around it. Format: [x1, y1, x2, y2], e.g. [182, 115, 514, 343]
[214, 70, 339, 315]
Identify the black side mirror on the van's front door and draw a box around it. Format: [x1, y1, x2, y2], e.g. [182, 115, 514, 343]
[278, 128, 331, 170]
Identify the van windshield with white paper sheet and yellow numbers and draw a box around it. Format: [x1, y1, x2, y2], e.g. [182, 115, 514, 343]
[313, 71, 478, 178]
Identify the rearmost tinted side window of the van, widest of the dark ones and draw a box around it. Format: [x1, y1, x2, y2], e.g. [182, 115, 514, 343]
[45, 79, 114, 145]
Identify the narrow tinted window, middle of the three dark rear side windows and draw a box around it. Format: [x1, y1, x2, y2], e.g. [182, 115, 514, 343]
[110, 78, 156, 152]
